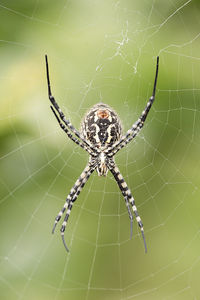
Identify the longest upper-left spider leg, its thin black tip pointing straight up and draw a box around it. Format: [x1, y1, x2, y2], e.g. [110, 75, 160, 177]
[45, 55, 97, 152]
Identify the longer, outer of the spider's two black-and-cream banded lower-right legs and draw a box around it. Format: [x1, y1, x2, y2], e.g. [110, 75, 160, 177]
[110, 166, 147, 252]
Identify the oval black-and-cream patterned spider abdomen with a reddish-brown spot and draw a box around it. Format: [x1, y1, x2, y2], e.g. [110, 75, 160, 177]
[81, 103, 122, 148]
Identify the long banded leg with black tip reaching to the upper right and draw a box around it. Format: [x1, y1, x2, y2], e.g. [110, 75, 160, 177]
[106, 56, 159, 156]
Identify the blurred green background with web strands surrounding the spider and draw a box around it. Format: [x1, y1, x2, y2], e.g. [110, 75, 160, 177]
[0, 0, 200, 300]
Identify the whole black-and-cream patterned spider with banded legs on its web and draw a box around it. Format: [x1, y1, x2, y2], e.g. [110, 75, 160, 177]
[45, 55, 159, 252]
